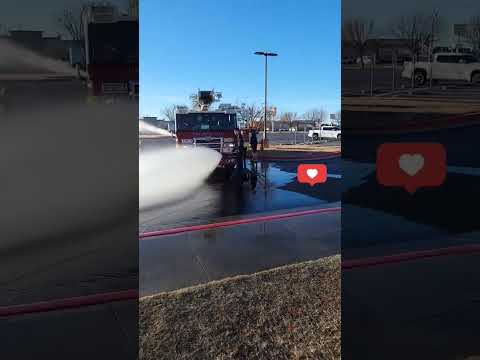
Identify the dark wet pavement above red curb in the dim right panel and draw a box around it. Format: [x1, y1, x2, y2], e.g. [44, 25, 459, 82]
[342, 160, 480, 259]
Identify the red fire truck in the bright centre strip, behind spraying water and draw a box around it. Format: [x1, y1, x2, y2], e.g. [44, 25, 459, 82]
[175, 91, 241, 173]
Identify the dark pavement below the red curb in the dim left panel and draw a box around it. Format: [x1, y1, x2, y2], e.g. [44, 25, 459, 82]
[0, 300, 138, 360]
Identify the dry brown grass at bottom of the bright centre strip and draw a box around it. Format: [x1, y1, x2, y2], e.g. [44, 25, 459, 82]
[139, 256, 340, 359]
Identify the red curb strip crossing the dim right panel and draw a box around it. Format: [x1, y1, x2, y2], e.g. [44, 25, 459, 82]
[342, 245, 480, 270]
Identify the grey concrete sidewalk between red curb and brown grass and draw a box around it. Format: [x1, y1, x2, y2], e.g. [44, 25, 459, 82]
[139, 212, 341, 297]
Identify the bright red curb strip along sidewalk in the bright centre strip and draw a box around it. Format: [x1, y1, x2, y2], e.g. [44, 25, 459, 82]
[139, 207, 342, 240]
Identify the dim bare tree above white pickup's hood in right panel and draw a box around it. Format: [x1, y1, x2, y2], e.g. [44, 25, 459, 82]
[391, 13, 434, 56]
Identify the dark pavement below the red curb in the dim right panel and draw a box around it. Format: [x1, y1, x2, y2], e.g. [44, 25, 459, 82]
[342, 254, 480, 360]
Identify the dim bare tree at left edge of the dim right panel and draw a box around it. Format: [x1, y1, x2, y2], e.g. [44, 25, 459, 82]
[342, 18, 374, 69]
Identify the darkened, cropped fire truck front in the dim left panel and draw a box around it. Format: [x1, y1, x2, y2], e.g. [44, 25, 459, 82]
[84, 6, 139, 102]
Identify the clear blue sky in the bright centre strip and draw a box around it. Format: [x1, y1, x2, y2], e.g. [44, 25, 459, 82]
[140, 0, 340, 117]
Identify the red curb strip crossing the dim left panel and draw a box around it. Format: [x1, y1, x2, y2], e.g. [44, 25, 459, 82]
[0, 289, 138, 317]
